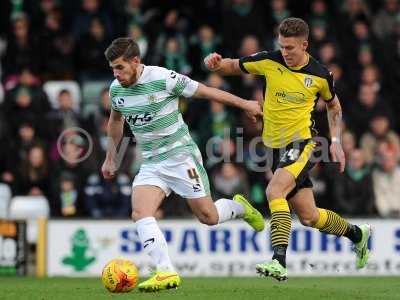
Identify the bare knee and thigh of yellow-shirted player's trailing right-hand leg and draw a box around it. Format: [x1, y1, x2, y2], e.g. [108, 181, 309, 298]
[289, 188, 319, 226]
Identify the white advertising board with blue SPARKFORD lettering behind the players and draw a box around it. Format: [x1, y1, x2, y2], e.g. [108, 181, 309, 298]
[47, 219, 400, 276]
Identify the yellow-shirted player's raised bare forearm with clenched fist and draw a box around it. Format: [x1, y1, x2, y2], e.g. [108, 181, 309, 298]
[204, 52, 243, 75]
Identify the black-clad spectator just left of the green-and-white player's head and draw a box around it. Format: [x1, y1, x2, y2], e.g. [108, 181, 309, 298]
[77, 17, 110, 81]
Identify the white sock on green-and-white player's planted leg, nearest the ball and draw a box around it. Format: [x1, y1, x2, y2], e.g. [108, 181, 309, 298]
[136, 217, 175, 272]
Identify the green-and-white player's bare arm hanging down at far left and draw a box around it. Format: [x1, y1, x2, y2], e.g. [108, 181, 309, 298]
[101, 109, 124, 179]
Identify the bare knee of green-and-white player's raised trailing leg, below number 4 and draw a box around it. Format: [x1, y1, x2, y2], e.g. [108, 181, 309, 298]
[187, 196, 218, 225]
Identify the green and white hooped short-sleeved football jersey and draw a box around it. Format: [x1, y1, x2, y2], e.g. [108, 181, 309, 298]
[110, 66, 198, 163]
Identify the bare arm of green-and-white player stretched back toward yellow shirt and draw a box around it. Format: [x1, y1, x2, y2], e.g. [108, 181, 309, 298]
[193, 83, 262, 122]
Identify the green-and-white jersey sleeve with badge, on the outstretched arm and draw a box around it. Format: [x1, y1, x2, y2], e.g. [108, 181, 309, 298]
[166, 70, 199, 97]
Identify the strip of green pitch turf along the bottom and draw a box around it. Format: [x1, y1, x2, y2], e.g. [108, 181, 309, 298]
[0, 277, 400, 300]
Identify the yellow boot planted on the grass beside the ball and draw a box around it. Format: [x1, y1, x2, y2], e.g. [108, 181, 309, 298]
[138, 272, 181, 292]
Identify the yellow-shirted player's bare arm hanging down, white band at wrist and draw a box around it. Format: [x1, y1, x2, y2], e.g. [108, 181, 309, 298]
[326, 96, 346, 172]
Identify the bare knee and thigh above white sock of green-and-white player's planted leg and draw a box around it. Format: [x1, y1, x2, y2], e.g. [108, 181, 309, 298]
[132, 185, 165, 221]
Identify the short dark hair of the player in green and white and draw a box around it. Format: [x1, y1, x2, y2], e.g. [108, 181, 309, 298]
[104, 38, 140, 61]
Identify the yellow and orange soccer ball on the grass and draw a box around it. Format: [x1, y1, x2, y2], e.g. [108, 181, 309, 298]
[101, 258, 139, 293]
